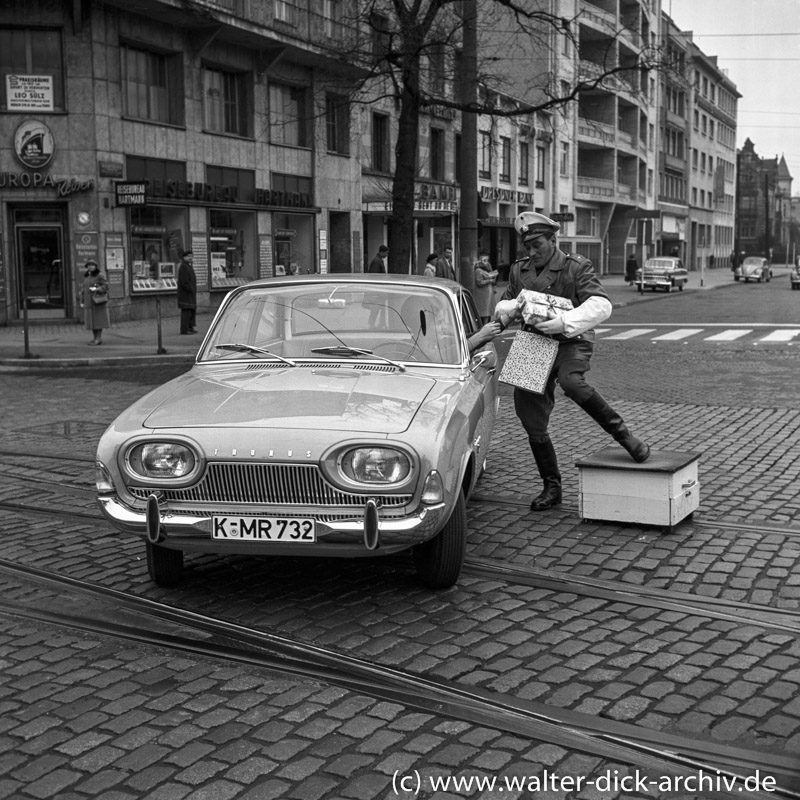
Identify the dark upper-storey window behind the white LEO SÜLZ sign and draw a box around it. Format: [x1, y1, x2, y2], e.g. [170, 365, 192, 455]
[0, 28, 66, 111]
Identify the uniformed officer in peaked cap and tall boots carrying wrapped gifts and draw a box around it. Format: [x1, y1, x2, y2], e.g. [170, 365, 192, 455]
[502, 211, 650, 511]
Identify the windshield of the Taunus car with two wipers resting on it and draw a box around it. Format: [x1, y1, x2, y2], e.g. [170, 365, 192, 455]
[200, 282, 464, 368]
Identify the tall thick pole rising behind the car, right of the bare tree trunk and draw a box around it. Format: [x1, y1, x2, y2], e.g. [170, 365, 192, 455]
[458, 0, 478, 291]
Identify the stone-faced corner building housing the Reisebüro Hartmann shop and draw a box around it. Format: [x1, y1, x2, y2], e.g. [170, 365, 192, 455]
[0, 0, 362, 324]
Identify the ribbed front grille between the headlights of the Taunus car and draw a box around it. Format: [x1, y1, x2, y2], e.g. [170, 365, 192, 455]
[130, 462, 411, 508]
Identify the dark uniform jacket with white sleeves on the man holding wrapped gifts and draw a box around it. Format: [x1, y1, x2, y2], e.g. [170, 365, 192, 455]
[501, 249, 611, 342]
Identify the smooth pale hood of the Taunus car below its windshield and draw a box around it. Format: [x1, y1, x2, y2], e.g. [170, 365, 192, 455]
[142, 367, 437, 434]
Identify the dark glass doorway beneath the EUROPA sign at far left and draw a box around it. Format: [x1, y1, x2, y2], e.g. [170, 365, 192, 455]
[13, 208, 69, 319]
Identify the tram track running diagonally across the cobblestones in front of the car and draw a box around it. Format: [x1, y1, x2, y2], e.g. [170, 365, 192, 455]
[0, 560, 800, 800]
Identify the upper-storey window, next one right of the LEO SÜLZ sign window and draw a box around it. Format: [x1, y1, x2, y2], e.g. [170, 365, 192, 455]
[121, 45, 184, 125]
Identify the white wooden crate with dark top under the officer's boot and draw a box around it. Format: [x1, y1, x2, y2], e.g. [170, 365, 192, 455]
[575, 447, 700, 532]
